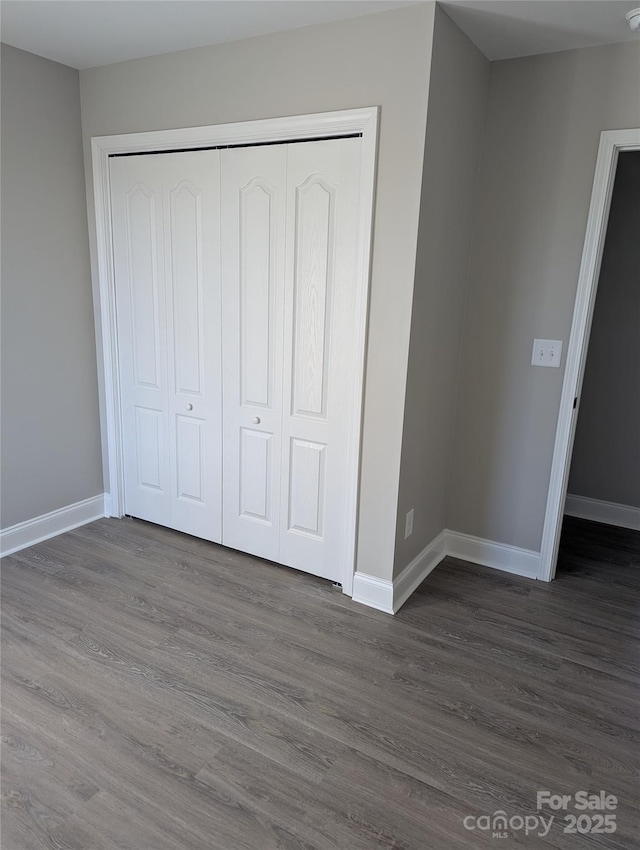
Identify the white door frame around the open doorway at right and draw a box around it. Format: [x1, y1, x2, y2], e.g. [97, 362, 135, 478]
[538, 129, 640, 581]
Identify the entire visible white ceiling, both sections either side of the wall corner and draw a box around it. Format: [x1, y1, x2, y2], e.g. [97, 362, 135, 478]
[0, 0, 640, 69]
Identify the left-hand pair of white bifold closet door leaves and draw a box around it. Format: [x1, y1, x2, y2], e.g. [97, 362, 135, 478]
[110, 151, 222, 542]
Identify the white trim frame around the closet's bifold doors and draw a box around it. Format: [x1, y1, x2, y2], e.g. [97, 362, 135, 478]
[91, 106, 379, 595]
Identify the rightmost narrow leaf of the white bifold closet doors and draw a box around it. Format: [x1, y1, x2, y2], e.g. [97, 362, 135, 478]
[278, 139, 361, 581]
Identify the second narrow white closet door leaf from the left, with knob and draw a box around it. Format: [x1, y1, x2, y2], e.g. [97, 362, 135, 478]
[162, 151, 222, 543]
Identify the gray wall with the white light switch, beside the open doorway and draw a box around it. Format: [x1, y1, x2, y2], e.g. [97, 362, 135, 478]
[449, 42, 640, 551]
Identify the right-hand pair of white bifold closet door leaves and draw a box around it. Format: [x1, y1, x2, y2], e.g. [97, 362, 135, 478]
[221, 138, 361, 581]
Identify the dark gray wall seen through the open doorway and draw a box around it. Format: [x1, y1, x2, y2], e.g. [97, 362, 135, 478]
[569, 152, 640, 508]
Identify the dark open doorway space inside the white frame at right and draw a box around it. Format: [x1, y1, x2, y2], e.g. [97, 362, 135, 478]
[558, 151, 640, 573]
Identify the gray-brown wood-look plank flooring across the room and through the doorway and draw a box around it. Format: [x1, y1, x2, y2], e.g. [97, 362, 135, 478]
[2, 520, 640, 850]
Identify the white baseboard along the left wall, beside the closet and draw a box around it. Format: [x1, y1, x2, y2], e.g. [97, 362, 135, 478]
[0, 493, 106, 557]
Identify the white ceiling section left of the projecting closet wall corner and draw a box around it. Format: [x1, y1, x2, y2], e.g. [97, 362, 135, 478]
[0, 0, 418, 68]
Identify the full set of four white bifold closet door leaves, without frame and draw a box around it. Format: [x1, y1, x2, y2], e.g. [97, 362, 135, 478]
[110, 137, 362, 581]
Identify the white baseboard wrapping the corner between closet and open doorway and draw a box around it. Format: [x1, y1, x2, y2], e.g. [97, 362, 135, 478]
[352, 529, 540, 614]
